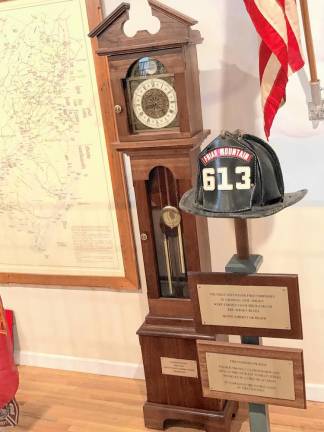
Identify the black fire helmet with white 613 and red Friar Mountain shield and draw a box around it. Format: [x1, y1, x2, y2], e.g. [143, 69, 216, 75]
[180, 131, 307, 218]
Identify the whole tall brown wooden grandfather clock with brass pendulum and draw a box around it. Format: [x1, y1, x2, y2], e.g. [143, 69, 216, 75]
[90, 0, 237, 432]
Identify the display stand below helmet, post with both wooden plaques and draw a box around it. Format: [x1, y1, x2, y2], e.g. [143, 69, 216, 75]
[189, 219, 306, 432]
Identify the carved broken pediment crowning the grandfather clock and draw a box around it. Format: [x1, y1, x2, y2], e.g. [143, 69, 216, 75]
[89, 0, 202, 55]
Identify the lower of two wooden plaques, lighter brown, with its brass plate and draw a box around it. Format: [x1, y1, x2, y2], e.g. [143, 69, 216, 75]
[197, 340, 306, 408]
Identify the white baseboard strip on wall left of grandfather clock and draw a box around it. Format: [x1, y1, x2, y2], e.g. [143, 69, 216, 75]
[15, 351, 144, 379]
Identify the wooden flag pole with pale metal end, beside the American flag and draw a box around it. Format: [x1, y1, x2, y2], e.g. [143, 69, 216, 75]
[300, 0, 322, 106]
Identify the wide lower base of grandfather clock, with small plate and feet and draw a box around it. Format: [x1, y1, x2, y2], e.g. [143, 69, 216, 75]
[137, 322, 237, 432]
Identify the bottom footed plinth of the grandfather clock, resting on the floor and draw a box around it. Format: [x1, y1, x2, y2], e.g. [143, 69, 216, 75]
[143, 401, 238, 432]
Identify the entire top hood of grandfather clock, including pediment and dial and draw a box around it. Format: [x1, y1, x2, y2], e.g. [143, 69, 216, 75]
[89, 0, 205, 148]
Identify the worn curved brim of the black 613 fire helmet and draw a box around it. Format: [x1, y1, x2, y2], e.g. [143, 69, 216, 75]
[179, 189, 307, 219]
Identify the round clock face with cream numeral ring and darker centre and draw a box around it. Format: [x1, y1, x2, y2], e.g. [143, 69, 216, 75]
[132, 78, 178, 129]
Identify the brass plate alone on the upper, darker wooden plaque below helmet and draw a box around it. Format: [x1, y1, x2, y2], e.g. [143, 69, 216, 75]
[197, 284, 291, 330]
